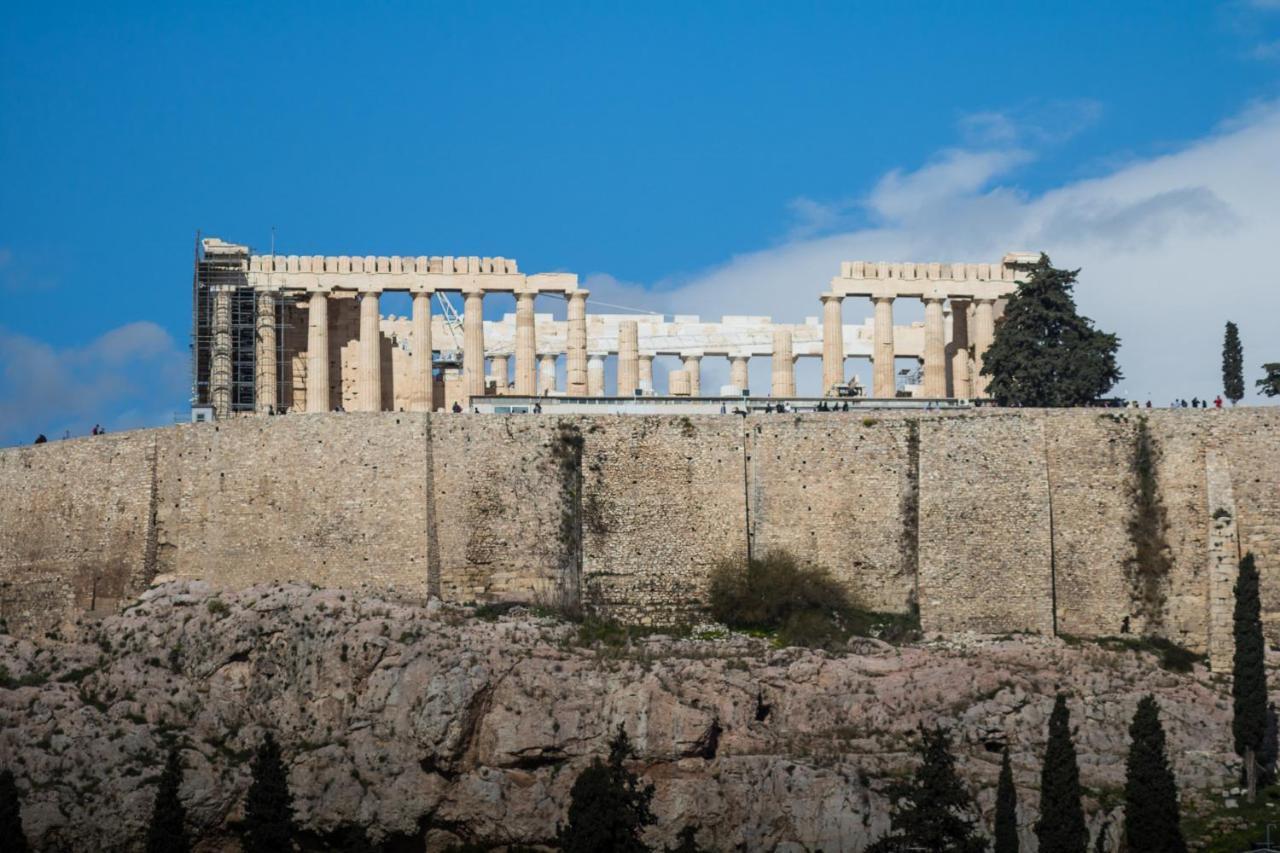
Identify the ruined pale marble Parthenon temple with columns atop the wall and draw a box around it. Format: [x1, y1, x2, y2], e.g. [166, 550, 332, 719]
[192, 237, 1038, 418]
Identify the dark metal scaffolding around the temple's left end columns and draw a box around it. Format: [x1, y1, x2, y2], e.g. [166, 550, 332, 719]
[191, 233, 293, 418]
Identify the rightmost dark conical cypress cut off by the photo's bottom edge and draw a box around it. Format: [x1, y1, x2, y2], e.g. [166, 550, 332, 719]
[1124, 694, 1187, 853]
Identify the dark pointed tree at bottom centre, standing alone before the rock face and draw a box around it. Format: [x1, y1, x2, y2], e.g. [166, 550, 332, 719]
[559, 725, 654, 853]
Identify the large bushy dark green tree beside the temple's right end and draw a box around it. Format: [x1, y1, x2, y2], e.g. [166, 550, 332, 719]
[982, 255, 1121, 406]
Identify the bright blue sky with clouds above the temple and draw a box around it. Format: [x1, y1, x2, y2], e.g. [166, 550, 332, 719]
[0, 0, 1280, 443]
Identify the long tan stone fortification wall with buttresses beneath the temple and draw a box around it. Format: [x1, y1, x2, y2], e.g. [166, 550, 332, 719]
[0, 409, 1280, 653]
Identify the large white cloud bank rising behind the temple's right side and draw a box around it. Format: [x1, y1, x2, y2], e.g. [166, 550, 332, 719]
[593, 102, 1280, 403]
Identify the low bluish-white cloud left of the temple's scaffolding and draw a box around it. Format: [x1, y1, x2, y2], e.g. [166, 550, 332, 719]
[0, 321, 189, 444]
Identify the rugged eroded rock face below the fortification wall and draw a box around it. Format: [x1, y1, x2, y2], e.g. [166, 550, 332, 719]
[0, 583, 1233, 853]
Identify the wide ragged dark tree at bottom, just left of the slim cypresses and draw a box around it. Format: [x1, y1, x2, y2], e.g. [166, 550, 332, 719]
[867, 726, 987, 853]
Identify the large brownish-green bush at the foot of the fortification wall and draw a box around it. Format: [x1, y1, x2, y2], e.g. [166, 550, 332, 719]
[709, 551, 919, 648]
